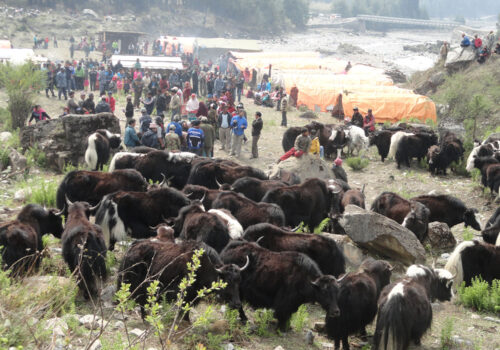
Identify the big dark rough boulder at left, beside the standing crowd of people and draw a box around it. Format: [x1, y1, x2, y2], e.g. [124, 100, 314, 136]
[20, 113, 120, 171]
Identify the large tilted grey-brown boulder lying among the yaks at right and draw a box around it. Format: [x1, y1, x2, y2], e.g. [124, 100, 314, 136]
[339, 205, 425, 265]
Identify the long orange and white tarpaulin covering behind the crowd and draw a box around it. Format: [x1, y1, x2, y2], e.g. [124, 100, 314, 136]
[231, 51, 436, 123]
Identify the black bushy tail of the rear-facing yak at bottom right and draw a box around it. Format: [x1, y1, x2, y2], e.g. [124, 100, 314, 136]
[373, 296, 410, 350]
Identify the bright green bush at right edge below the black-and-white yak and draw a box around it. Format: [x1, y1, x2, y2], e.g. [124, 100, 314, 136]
[458, 277, 500, 313]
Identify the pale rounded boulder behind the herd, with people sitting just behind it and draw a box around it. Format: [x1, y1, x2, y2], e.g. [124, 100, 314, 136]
[269, 154, 335, 181]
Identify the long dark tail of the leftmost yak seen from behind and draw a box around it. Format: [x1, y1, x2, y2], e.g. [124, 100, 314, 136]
[73, 233, 107, 300]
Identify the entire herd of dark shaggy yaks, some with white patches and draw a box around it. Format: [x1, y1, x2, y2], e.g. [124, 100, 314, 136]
[0, 122, 500, 349]
